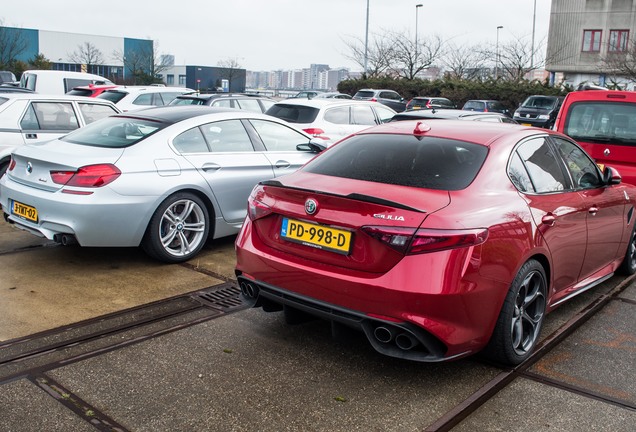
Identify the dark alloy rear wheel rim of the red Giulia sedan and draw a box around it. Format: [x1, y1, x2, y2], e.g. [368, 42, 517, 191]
[510, 271, 545, 356]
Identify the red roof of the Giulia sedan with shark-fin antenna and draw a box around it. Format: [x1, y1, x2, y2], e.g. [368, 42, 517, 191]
[356, 120, 548, 146]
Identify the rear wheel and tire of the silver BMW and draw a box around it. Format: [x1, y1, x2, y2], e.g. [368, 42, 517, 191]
[142, 192, 210, 263]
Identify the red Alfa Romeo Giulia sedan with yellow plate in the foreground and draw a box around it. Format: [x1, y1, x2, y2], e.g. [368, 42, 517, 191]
[236, 120, 636, 365]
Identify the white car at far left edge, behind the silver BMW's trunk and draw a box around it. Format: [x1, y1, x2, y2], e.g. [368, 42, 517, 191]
[0, 93, 120, 177]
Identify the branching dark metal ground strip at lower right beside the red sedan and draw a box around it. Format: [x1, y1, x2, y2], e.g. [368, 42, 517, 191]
[425, 276, 636, 432]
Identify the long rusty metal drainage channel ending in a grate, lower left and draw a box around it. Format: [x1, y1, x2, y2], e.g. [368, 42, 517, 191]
[0, 283, 246, 385]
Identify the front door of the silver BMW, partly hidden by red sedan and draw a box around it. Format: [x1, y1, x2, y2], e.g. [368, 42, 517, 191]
[249, 119, 315, 177]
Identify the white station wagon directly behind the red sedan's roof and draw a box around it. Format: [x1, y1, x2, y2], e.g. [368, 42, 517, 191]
[265, 98, 396, 146]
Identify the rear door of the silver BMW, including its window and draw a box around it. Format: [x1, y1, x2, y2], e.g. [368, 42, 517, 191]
[172, 119, 274, 223]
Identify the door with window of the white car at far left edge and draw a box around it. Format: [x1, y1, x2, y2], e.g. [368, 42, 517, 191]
[20, 100, 79, 143]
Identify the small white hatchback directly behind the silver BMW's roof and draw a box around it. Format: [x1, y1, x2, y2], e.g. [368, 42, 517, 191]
[96, 85, 196, 111]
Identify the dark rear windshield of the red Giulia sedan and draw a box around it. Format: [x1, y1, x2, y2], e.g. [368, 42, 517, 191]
[303, 134, 488, 190]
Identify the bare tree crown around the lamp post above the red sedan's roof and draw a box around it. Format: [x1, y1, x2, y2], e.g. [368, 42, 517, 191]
[385, 31, 443, 80]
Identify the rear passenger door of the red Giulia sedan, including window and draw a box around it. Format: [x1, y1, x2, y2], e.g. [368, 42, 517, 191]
[508, 137, 588, 294]
